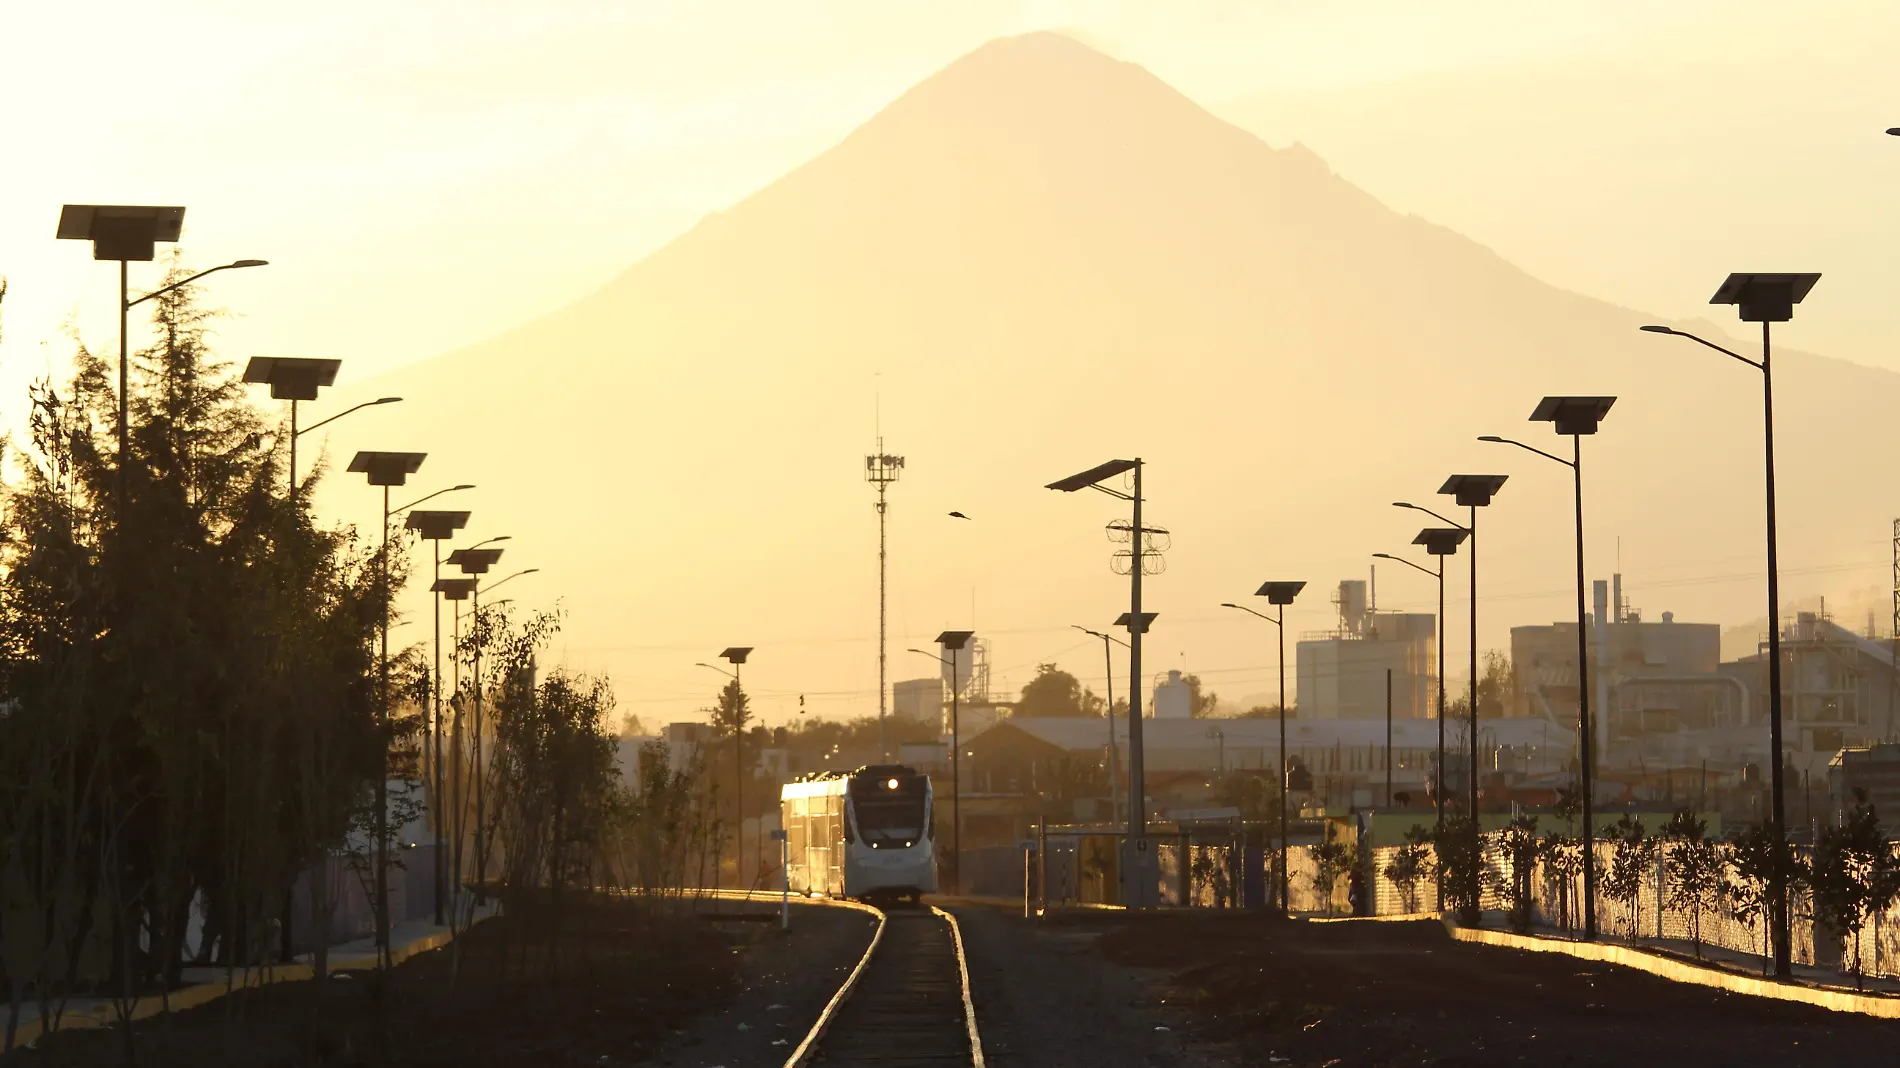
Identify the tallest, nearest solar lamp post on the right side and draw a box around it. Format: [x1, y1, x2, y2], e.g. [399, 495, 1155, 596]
[1644, 271, 1816, 977]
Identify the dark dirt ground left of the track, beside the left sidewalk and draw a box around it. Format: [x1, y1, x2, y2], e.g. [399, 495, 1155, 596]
[8, 899, 756, 1068]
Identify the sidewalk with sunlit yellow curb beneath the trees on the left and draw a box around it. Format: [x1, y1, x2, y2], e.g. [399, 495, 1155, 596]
[0, 905, 496, 1047]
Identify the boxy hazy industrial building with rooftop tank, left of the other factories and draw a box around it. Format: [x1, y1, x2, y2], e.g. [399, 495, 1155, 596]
[1294, 578, 1436, 720]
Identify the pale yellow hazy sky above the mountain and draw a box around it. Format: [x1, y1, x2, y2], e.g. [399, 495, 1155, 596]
[0, 0, 1900, 722]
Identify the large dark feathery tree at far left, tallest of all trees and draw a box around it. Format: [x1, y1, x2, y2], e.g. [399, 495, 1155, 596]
[0, 260, 391, 1015]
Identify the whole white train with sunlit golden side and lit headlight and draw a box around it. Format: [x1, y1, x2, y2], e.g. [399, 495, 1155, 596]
[779, 764, 937, 903]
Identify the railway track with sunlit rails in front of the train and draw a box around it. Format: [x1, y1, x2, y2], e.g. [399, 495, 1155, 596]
[785, 906, 984, 1068]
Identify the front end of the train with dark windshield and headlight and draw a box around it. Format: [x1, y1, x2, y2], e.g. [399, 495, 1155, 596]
[844, 764, 937, 901]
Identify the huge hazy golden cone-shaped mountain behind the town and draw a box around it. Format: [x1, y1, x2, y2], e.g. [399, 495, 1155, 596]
[311, 34, 1900, 718]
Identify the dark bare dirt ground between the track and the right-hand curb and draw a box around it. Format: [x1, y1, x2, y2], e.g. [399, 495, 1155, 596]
[1094, 912, 1900, 1068]
